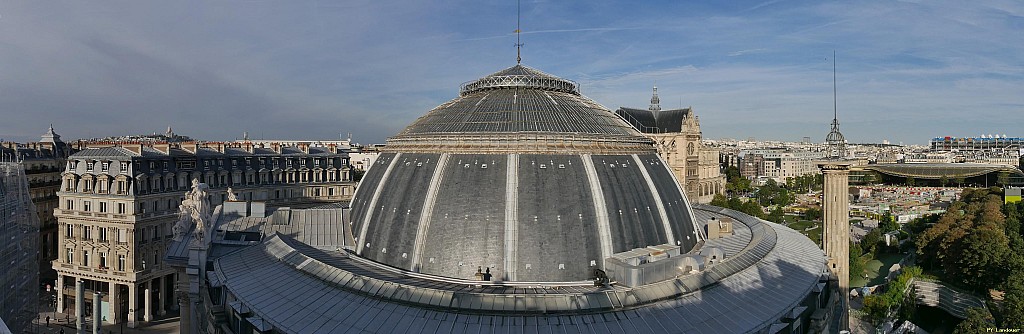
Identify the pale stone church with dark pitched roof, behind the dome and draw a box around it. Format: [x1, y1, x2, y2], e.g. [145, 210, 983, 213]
[615, 87, 725, 203]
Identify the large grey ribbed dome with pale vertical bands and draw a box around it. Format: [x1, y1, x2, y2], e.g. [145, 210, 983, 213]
[350, 65, 701, 282]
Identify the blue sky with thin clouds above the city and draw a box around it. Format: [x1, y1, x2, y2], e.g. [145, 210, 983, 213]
[0, 0, 1024, 143]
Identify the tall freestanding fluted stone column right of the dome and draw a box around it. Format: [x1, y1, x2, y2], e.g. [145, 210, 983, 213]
[818, 161, 850, 330]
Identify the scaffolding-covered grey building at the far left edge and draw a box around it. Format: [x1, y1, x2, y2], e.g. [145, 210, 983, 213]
[0, 162, 39, 333]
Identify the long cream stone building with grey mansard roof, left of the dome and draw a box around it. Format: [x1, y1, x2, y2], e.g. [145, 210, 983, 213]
[52, 139, 355, 327]
